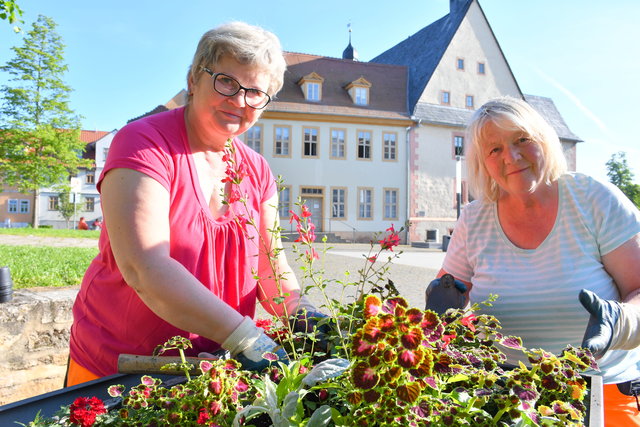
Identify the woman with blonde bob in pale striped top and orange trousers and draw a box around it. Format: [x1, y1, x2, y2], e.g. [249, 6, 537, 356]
[427, 97, 640, 426]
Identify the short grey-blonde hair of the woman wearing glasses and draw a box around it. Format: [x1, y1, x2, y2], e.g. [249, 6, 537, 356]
[187, 21, 287, 96]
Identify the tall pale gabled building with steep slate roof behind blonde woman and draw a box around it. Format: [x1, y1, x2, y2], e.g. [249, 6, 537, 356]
[371, 0, 581, 242]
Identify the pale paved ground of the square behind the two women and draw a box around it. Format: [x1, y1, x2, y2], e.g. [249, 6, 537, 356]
[0, 234, 444, 315]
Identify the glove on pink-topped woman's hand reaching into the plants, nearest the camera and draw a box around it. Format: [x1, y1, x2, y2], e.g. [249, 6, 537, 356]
[222, 316, 289, 372]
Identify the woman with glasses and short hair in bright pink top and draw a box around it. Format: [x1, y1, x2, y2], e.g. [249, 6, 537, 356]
[67, 22, 321, 385]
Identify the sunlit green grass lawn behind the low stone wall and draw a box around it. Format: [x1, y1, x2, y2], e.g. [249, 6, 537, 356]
[0, 228, 100, 289]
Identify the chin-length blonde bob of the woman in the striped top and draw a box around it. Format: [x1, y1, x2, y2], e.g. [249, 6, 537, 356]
[466, 96, 567, 202]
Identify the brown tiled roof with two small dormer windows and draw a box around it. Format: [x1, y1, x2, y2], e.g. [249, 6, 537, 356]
[267, 52, 409, 119]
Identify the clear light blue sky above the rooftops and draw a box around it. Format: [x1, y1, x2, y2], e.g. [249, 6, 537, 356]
[0, 0, 640, 183]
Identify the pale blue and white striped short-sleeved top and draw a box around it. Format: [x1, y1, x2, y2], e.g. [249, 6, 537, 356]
[443, 173, 640, 383]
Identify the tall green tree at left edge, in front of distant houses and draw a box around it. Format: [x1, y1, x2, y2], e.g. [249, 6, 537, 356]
[0, 15, 90, 228]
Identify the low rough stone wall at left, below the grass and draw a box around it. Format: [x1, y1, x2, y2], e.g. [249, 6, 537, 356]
[0, 287, 78, 405]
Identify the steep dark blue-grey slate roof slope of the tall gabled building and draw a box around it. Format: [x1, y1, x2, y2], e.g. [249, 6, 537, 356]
[370, 0, 473, 111]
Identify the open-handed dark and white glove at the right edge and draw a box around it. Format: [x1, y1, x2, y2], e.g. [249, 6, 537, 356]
[579, 289, 640, 359]
